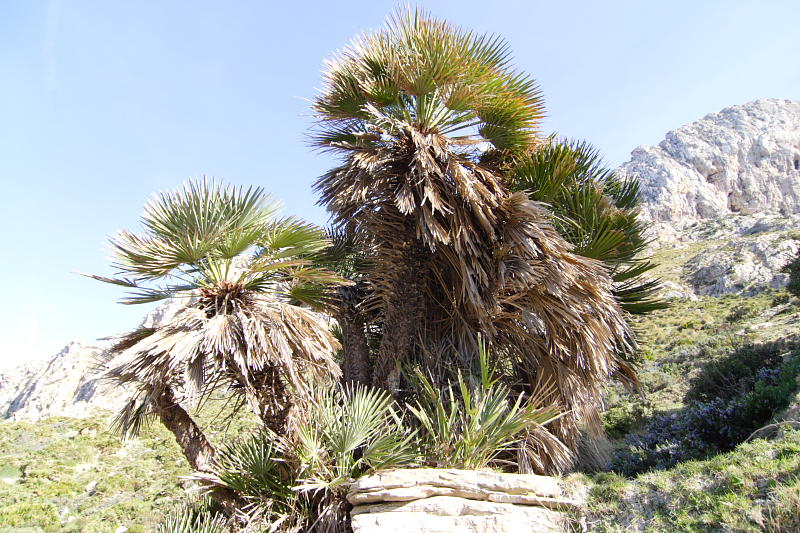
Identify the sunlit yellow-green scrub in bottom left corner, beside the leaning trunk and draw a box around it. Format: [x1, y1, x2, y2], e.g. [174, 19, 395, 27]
[0, 418, 190, 533]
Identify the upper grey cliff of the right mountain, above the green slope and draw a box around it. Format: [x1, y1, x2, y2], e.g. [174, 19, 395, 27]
[620, 99, 800, 225]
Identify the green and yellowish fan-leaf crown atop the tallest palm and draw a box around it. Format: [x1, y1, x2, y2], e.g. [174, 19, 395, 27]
[313, 6, 543, 150]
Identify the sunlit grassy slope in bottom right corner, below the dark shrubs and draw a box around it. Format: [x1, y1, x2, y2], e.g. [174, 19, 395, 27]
[586, 430, 800, 533]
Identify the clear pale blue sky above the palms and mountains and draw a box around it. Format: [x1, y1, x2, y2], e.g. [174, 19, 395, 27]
[0, 0, 800, 367]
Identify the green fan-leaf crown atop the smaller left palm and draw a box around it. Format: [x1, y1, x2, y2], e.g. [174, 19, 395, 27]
[90, 179, 341, 305]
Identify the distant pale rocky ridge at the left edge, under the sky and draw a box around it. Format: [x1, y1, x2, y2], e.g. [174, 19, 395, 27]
[0, 342, 121, 421]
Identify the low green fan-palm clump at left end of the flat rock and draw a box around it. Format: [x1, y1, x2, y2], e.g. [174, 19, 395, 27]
[192, 384, 419, 533]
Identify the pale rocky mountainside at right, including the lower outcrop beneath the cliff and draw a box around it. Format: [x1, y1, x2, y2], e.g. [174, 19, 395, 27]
[619, 99, 800, 298]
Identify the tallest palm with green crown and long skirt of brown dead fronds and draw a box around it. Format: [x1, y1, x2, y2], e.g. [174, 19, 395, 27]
[314, 10, 632, 466]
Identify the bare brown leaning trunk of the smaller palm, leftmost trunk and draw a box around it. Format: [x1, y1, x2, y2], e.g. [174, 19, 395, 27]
[155, 387, 244, 516]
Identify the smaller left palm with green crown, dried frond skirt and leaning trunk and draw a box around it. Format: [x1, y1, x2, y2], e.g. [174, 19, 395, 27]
[91, 179, 341, 470]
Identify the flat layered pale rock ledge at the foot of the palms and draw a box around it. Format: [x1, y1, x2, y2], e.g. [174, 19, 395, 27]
[347, 468, 580, 533]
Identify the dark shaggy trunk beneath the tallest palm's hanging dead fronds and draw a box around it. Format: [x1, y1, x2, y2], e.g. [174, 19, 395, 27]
[372, 243, 427, 396]
